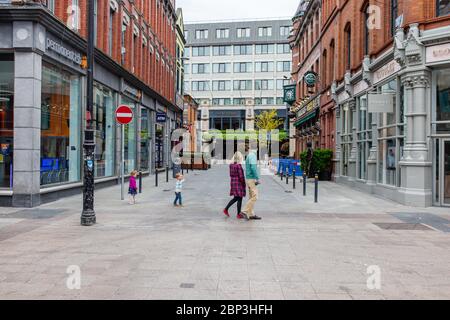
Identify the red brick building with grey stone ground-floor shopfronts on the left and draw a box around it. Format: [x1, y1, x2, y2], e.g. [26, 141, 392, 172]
[0, 0, 182, 206]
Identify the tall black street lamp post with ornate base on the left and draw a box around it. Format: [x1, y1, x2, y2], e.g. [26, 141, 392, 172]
[81, 0, 96, 226]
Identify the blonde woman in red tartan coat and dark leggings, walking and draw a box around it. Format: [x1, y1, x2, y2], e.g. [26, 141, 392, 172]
[223, 151, 246, 219]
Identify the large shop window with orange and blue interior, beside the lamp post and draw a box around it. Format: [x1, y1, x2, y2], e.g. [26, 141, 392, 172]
[41, 62, 82, 185]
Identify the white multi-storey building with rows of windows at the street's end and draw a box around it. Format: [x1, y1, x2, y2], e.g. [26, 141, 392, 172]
[184, 20, 292, 131]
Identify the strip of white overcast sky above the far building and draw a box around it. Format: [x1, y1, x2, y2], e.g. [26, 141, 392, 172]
[176, 0, 300, 22]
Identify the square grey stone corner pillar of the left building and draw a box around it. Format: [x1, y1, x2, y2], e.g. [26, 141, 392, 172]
[12, 21, 45, 207]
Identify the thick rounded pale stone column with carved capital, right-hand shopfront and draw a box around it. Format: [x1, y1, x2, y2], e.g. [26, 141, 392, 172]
[399, 68, 433, 207]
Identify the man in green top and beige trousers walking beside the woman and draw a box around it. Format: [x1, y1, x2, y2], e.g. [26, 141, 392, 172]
[242, 145, 261, 220]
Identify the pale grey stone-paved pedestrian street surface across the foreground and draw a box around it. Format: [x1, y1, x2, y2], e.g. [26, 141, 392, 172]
[0, 166, 450, 300]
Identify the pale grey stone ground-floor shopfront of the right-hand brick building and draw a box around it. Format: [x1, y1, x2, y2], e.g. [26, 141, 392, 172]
[332, 24, 450, 207]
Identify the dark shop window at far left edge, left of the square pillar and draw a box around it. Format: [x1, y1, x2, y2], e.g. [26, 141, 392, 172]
[0, 54, 14, 188]
